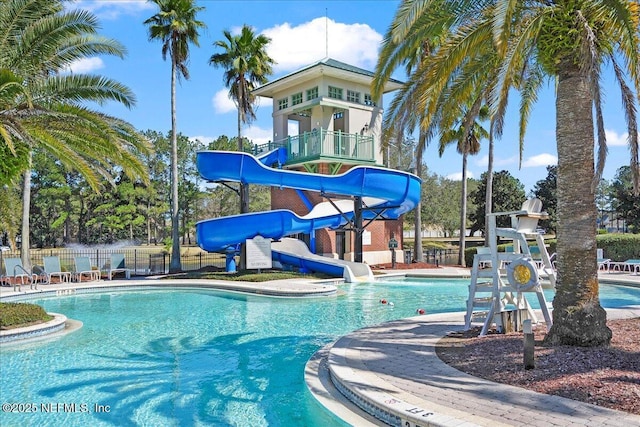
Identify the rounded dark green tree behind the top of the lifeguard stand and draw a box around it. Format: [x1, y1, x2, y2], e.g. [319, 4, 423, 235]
[469, 170, 525, 235]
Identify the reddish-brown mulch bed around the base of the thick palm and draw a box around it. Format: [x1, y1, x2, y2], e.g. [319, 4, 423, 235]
[436, 318, 640, 415]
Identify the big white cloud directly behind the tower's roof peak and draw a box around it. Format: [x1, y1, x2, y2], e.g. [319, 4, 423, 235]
[262, 18, 382, 72]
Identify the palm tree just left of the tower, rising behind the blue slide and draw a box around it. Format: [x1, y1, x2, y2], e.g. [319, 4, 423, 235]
[209, 25, 275, 213]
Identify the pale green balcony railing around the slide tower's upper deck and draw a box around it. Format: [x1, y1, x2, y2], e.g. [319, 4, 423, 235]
[255, 129, 375, 164]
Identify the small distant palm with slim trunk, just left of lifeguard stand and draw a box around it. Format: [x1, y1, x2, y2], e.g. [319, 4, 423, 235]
[438, 107, 489, 267]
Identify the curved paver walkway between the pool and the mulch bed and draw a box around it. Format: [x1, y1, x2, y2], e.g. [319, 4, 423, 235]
[328, 306, 640, 427]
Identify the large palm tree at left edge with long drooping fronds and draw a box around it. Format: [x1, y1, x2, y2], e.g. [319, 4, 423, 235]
[0, 0, 150, 266]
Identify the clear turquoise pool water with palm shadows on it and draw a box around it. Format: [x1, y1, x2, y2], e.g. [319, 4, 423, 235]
[0, 279, 640, 427]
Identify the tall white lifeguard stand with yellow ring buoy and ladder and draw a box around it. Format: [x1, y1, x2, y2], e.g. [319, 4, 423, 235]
[465, 198, 556, 336]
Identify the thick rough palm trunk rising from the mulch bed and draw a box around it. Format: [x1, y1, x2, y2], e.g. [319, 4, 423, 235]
[545, 62, 611, 347]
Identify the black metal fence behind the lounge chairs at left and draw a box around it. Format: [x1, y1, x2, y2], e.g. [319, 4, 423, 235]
[0, 248, 225, 276]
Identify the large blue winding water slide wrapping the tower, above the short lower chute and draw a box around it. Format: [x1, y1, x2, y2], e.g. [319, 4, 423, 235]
[196, 151, 421, 252]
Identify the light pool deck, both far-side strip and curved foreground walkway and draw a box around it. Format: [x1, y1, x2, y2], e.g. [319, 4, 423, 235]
[0, 264, 640, 427]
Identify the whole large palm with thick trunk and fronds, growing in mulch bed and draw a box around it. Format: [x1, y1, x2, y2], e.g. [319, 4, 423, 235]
[380, 0, 640, 346]
